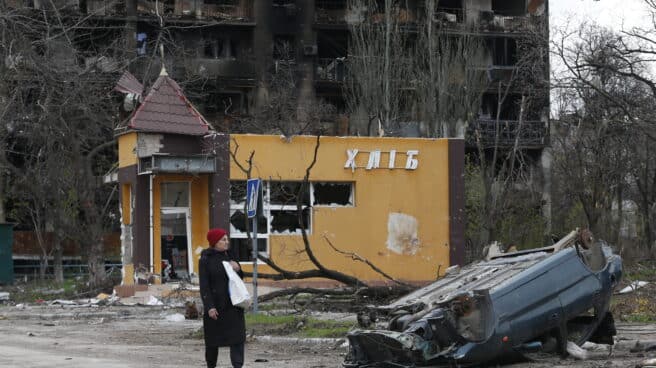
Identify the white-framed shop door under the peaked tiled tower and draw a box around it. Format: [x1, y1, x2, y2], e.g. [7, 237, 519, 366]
[161, 208, 193, 282]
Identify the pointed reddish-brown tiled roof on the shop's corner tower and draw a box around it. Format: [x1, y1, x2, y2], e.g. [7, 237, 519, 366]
[128, 72, 209, 135]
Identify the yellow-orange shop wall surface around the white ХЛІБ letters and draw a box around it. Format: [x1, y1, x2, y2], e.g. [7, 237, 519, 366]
[229, 135, 449, 281]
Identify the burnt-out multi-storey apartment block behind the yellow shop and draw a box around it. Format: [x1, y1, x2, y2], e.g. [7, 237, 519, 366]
[7, 0, 549, 146]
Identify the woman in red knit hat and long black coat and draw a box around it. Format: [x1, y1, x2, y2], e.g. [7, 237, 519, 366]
[198, 229, 246, 368]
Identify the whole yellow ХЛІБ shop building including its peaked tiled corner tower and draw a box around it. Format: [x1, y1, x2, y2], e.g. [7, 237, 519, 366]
[117, 69, 464, 284]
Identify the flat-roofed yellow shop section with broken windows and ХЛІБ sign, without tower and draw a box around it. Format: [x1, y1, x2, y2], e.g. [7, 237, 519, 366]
[230, 135, 464, 282]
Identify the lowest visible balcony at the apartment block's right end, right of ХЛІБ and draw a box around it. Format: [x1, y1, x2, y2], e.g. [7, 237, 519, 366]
[466, 119, 549, 149]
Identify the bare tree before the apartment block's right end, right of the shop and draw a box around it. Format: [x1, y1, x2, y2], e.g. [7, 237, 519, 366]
[470, 19, 549, 247]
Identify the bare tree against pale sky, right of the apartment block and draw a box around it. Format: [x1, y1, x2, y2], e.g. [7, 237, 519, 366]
[552, 20, 656, 247]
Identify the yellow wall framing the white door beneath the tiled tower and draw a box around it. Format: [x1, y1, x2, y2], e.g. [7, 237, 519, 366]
[153, 175, 209, 275]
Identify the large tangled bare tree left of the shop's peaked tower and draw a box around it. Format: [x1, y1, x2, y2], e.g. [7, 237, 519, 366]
[0, 2, 124, 285]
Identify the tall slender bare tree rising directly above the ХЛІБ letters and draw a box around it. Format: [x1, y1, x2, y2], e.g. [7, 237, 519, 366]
[344, 0, 413, 135]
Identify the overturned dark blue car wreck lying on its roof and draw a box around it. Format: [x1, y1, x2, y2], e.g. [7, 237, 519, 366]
[342, 230, 622, 368]
